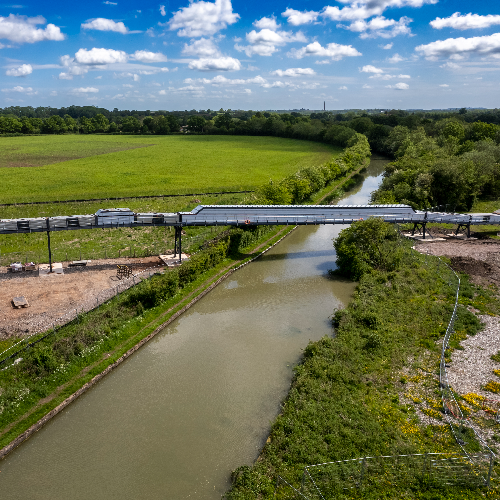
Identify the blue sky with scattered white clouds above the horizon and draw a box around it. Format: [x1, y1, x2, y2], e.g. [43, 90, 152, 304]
[0, 0, 500, 111]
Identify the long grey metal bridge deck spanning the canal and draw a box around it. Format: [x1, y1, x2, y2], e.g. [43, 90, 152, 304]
[0, 205, 500, 234]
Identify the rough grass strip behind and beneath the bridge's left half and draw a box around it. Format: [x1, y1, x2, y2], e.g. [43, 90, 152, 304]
[0, 194, 244, 265]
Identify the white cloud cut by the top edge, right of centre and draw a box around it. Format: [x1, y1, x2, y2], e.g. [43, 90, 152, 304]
[321, 0, 438, 21]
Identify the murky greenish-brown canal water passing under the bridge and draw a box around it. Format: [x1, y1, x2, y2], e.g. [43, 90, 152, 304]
[0, 155, 386, 500]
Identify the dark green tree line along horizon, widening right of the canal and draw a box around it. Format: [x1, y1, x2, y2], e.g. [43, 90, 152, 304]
[0, 106, 500, 210]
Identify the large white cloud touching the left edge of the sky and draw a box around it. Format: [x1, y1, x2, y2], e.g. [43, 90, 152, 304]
[0, 14, 66, 43]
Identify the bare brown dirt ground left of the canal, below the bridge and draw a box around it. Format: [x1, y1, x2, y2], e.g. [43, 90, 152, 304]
[0, 257, 165, 338]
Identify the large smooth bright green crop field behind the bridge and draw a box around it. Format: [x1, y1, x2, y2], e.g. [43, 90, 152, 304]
[0, 135, 340, 204]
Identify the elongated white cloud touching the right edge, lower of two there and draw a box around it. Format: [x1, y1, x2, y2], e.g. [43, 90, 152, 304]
[415, 33, 500, 60]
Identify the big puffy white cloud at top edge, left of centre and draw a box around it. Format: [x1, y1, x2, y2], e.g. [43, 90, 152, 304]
[168, 0, 240, 37]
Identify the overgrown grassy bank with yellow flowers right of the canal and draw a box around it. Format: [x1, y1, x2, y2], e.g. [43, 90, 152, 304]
[227, 233, 500, 499]
